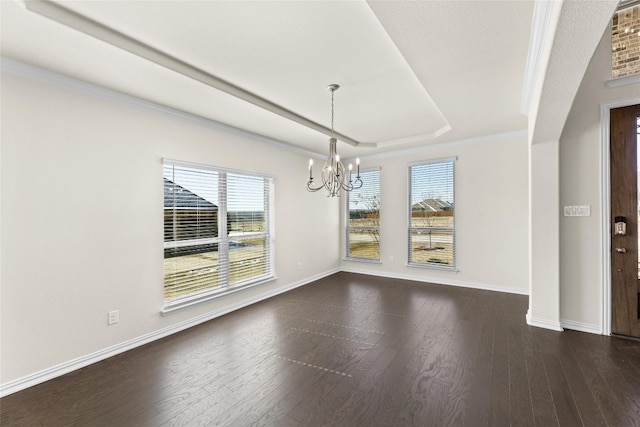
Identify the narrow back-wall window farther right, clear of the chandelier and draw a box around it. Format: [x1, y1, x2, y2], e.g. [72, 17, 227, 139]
[408, 159, 455, 269]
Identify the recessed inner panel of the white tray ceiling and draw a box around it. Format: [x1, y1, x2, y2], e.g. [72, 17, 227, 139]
[23, 1, 448, 143]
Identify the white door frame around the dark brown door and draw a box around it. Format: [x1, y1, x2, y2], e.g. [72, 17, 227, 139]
[600, 98, 640, 335]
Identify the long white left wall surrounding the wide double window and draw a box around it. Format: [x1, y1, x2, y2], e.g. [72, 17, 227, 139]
[0, 69, 340, 385]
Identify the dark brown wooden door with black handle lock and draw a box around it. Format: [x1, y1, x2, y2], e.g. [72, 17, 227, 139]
[610, 105, 640, 337]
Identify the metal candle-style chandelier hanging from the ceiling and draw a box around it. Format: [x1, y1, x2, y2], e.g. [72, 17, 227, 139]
[307, 84, 362, 197]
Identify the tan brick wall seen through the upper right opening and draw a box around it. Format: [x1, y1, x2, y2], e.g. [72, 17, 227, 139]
[611, 6, 640, 78]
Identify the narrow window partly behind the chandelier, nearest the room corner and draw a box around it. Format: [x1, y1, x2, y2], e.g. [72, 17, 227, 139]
[347, 169, 380, 261]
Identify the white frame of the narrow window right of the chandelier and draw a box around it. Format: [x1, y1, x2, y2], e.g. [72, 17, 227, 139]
[407, 157, 458, 272]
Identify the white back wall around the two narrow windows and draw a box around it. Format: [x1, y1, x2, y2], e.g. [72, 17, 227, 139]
[342, 131, 529, 296]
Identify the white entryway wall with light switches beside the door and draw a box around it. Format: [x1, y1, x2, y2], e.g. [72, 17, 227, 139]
[559, 30, 640, 332]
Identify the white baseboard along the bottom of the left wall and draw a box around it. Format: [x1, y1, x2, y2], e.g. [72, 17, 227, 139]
[0, 268, 340, 397]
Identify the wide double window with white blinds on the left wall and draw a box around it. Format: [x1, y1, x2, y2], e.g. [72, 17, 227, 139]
[163, 160, 274, 311]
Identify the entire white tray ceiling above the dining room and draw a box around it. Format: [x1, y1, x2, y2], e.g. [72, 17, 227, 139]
[0, 0, 533, 157]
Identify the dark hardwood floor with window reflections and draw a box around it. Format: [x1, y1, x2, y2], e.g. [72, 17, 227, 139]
[0, 273, 640, 427]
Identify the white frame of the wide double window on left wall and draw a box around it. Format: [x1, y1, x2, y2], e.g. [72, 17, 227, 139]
[161, 158, 276, 315]
